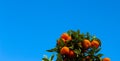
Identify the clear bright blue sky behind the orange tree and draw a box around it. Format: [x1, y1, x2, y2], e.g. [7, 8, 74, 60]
[0, 0, 120, 61]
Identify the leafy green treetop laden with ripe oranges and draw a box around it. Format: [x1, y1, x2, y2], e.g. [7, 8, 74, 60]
[43, 30, 110, 61]
